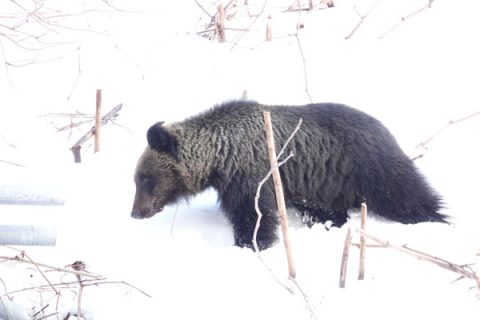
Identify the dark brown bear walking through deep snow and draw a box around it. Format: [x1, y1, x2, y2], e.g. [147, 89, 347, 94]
[132, 101, 447, 249]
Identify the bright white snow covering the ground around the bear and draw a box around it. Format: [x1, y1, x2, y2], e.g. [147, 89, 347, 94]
[0, 0, 480, 320]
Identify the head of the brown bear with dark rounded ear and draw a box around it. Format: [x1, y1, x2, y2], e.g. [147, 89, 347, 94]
[132, 122, 188, 219]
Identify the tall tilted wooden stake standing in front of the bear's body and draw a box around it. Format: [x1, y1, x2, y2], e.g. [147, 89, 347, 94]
[263, 112, 296, 279]
